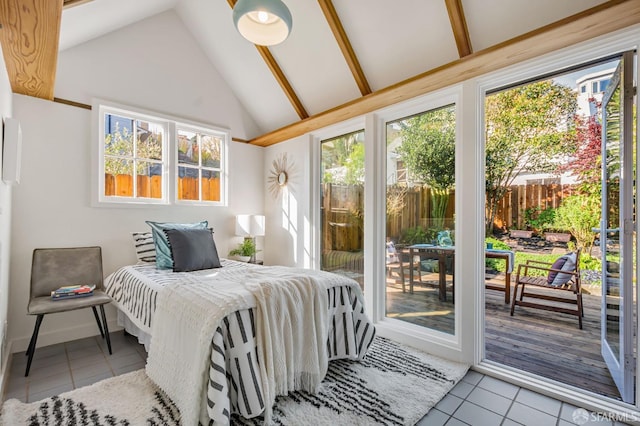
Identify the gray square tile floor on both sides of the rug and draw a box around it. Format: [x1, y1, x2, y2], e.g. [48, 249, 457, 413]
[4, 331, 624, 426]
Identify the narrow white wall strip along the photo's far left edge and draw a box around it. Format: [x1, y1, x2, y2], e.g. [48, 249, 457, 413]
[0, 45, 12, 386]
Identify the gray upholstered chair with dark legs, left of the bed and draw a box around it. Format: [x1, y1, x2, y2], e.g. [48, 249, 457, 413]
[24, 247, 112, 376]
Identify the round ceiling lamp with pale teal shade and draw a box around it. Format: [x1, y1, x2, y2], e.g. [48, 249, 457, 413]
[233, 0, 293, 46]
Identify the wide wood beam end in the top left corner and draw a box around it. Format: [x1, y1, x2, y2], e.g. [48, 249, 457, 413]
[0, 0, 62, 100]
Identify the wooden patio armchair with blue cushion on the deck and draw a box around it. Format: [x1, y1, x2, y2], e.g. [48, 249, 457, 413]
[511, 250, 584, 330]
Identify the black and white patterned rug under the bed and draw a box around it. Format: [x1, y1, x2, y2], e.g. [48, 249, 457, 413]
[0, 337, 468, 426]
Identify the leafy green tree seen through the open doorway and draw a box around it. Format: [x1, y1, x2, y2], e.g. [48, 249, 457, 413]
[485, 80, 576, 234]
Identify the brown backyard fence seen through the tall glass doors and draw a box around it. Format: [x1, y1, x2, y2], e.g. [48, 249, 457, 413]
[322, 184, 574, 251]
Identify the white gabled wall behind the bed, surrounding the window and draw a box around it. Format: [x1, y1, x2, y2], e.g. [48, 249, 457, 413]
[8, 12, 264, 351]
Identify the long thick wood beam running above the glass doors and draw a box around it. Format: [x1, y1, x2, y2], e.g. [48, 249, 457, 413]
[251, 0, 640, 146]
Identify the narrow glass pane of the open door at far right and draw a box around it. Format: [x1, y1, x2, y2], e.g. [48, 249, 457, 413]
[600, 80, 621, 359]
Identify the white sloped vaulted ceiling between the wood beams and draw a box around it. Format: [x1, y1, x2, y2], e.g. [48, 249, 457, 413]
[60, 0, 605, 136]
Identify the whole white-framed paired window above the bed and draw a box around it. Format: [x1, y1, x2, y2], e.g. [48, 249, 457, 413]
[94, 100, 229, 205]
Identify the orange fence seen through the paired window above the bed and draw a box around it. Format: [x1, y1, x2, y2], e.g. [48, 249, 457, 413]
[104, 174, 220, 201]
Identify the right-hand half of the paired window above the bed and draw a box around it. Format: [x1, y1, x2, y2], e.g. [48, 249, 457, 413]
[176, 128, 224, 201]
